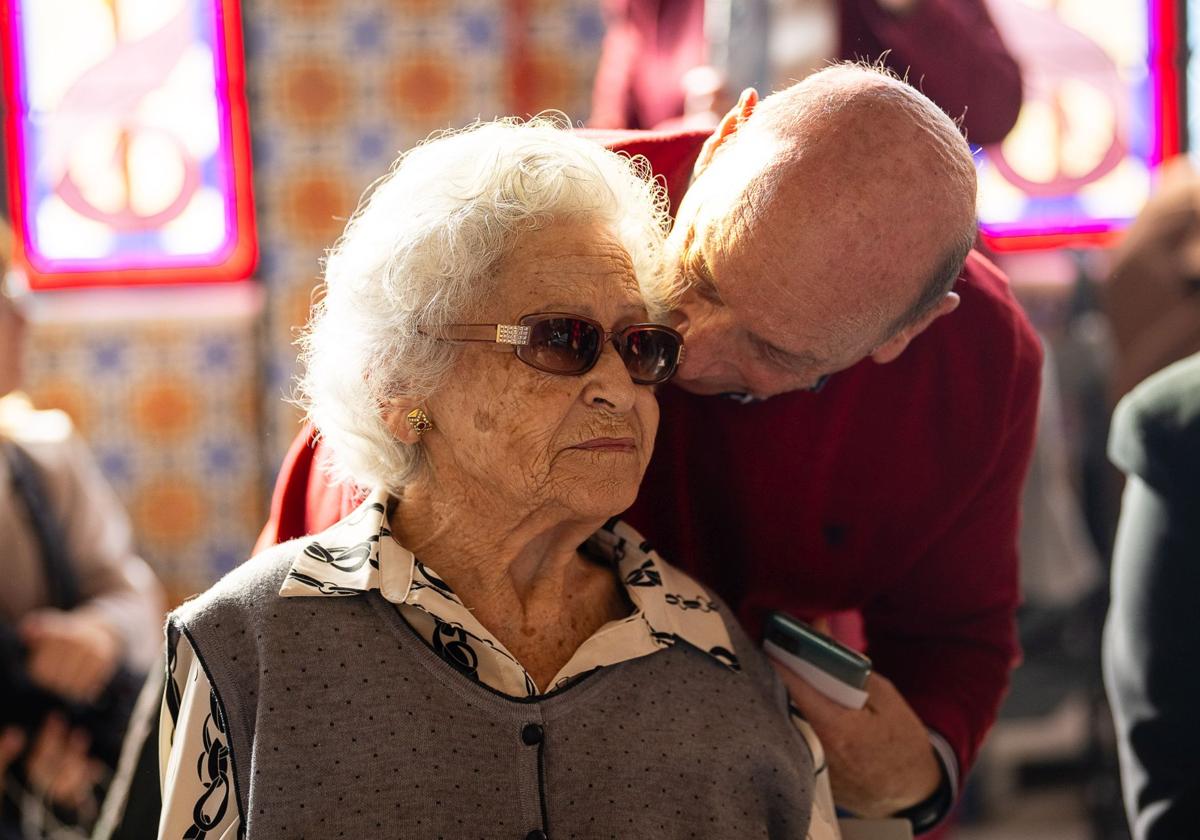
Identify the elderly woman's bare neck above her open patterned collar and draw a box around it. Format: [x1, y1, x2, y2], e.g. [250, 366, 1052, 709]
[391, 484, 630, 686]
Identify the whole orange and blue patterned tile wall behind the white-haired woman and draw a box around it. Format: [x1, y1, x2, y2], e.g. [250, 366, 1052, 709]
[21, 0, 604, 598]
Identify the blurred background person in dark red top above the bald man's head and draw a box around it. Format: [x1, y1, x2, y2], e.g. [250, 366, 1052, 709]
[588, 0, 1021, 145]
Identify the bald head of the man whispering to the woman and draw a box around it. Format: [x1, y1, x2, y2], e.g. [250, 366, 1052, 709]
[672, 65, 976, 392]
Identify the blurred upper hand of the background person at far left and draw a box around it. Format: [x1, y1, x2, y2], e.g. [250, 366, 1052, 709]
[20, 610, 121, 703]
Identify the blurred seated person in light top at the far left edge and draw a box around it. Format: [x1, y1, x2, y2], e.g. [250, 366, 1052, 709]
[0, 253, 169, 840]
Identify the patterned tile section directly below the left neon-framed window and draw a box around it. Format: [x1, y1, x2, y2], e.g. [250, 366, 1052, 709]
[26, 293, 265, 600]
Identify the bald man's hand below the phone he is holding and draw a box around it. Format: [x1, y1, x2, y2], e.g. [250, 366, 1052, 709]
[772, 660, 942, 818]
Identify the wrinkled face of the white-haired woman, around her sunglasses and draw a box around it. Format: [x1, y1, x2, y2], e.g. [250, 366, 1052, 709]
[424, 223, 659, 518]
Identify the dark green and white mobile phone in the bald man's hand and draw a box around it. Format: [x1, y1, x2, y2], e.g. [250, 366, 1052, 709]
[762, 611, 871, 709]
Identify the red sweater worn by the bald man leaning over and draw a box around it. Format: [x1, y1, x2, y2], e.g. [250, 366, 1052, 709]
[260, 132, 1042, 773]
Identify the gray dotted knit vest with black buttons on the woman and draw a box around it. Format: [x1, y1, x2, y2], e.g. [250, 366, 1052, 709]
[169, 542, 814, 840]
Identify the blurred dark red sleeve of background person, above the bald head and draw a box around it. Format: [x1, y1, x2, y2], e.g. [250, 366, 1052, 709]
[841, 0, 1021, 145]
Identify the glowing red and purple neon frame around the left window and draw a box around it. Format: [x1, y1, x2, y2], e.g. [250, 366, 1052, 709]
[0, 0, 258, 290]
